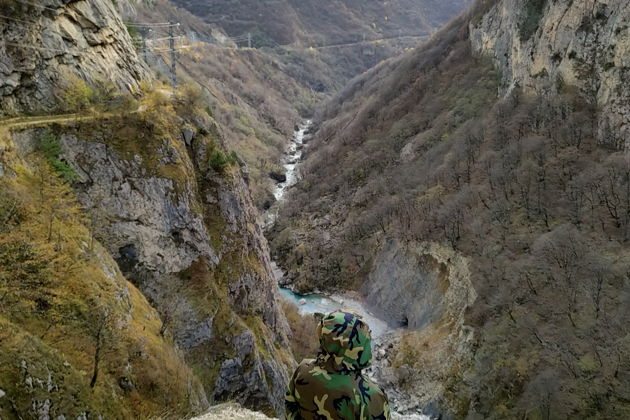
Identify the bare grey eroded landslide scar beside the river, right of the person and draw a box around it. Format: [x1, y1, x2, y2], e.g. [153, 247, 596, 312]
[362, 240, 477, 418]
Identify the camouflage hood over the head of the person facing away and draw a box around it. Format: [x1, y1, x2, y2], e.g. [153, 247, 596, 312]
[317, 310, 372, 372]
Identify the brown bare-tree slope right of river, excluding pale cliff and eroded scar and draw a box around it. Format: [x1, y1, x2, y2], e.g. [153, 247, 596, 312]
[273, 2, 630, 419]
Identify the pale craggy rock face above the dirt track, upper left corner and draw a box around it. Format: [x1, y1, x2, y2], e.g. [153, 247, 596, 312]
[0, 0, 150, 115]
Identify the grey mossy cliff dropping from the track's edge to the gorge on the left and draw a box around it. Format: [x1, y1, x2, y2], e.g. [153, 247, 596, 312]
[10, 106, 290, 411]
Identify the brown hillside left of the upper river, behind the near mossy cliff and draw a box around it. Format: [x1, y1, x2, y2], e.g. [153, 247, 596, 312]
[179, 43, 317, 208]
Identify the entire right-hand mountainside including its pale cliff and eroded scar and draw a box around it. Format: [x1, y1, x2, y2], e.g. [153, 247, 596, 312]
[272, 0, 630, 419]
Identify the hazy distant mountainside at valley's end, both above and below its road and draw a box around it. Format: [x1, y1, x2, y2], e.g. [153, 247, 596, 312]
[168, 0, 470, 94]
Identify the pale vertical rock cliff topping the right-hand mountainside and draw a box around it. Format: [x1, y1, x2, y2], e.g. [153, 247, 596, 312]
[470, 0, 630, 149]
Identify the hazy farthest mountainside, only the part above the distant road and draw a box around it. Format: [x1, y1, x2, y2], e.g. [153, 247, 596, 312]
[170, 0, 470, 45]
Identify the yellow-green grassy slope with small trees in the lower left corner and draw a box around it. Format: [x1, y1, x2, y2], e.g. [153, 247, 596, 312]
[0, 132, 208, 419]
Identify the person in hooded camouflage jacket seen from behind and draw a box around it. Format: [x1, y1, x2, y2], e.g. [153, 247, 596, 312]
[285, 310, 390, 420]
